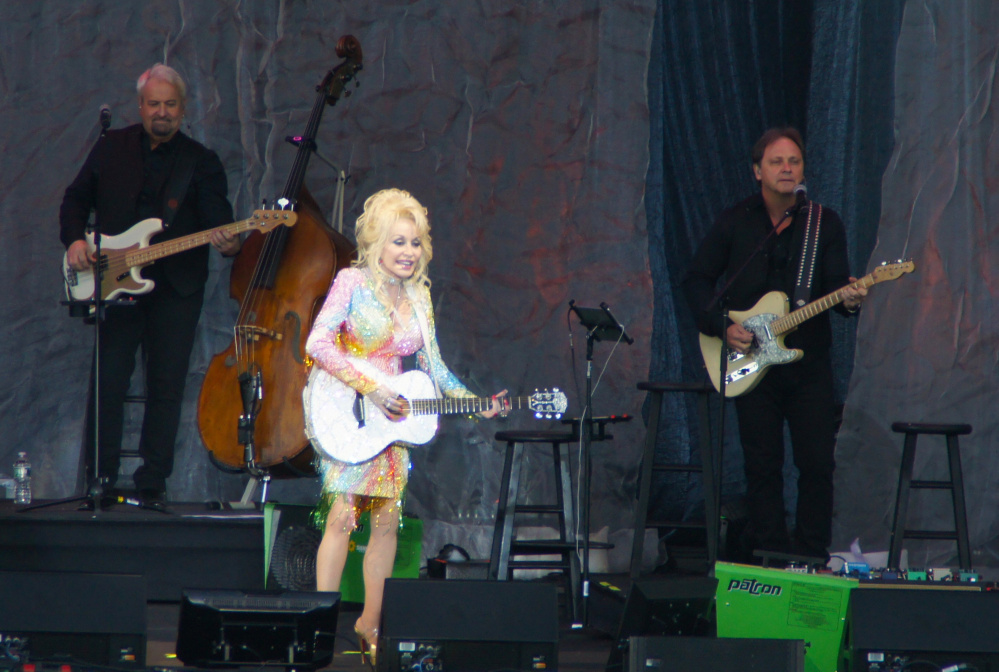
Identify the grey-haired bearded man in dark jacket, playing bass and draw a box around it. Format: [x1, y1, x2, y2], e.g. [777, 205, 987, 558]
[59, 64, 240, 505]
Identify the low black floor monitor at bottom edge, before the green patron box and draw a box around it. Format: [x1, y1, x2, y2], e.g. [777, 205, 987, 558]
[625, 637, 805, 672]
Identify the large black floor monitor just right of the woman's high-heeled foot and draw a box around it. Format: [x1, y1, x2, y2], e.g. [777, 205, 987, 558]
[378, 579, 558, 672]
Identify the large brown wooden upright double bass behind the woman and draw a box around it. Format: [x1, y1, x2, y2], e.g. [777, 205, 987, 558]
[198, 35, 362, 476]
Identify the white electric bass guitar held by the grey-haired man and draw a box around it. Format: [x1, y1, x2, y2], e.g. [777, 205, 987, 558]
[62, 210, 298, 301]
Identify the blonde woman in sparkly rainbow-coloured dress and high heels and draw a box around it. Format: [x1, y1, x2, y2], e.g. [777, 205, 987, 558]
[306, 189, 506, 655]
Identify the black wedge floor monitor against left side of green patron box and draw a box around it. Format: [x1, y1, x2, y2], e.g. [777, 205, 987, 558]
[607, 576, 718, 672]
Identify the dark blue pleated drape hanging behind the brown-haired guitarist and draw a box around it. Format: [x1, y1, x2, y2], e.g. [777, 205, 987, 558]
[646, 0, 902, 532]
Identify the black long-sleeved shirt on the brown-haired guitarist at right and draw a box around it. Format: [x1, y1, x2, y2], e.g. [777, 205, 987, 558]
[681, 194, 850, 359]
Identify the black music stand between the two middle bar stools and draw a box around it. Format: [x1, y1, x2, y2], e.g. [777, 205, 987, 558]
[569, 301, 635, 627]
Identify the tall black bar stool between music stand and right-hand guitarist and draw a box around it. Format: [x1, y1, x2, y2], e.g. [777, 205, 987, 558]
[631, 382, 718, 579]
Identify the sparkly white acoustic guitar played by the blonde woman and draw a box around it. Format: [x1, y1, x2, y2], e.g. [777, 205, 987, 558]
[302, 366, 568, 464]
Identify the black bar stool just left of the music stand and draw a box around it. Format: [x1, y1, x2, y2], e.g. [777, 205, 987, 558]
[489, 431, 580, 618]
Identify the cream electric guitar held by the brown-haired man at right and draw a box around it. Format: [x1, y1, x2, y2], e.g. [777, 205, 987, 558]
[700, 261, 916, 397]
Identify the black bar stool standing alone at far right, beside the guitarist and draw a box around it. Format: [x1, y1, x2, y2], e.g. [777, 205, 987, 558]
[888, 422, 971, 570]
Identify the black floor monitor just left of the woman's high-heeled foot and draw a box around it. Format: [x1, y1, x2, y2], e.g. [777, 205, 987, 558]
[177, 590, 340, 670]
